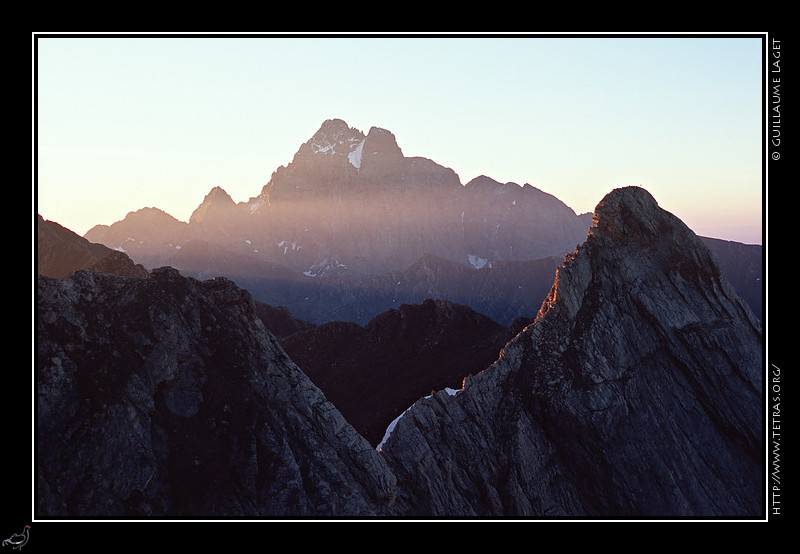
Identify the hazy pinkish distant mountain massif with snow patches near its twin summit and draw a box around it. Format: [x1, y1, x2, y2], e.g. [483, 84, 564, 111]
[79, 119, 762, 325]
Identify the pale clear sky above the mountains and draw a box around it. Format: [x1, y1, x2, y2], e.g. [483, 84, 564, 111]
[34, 35, 764, 243]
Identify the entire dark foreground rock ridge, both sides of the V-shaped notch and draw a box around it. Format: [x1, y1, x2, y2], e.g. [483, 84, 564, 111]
[36, 188, 763, 517]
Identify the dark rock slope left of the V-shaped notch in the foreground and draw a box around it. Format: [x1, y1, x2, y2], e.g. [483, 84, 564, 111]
[36, 268, 395, 518]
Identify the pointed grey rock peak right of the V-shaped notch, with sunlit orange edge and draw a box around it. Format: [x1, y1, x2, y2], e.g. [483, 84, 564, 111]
[382, 187, 764, 517]
